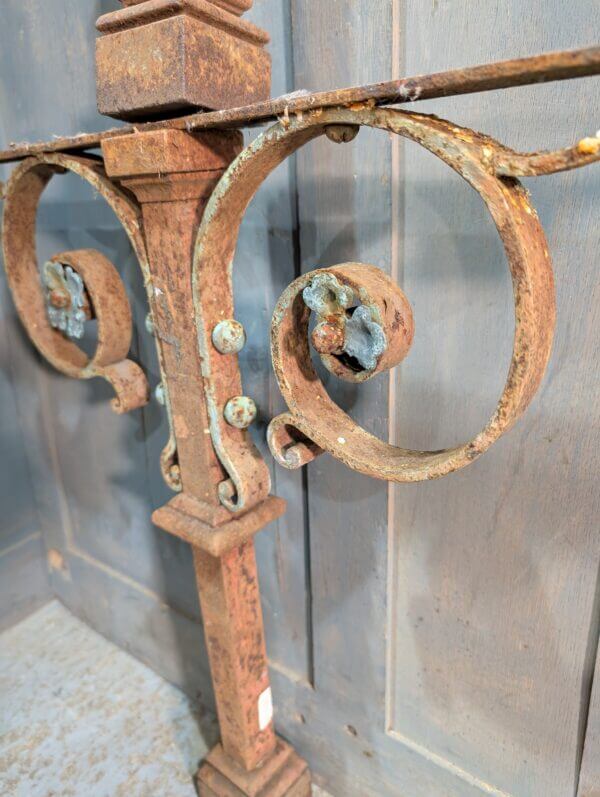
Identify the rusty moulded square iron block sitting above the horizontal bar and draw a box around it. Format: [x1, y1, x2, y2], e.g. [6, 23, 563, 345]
[96, 0, 271, 120]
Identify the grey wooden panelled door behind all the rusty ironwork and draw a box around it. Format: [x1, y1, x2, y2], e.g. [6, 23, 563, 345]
[0, 0, 600, 797]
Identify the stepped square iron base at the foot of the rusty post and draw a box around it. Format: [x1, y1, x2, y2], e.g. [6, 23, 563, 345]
[196, 739, 311, 797]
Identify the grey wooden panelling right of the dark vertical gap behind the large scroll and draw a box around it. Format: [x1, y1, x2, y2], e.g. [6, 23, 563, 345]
[286, 0, 600, 797]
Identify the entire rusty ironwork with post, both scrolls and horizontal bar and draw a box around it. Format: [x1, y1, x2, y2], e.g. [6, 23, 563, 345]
[0, 12, 600, 797]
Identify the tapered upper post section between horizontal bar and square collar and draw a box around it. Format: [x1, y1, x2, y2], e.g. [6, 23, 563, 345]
[103, 123, 270, 510]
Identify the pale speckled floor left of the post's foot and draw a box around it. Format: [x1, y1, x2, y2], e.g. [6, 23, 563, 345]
[0, 601, 328, 797]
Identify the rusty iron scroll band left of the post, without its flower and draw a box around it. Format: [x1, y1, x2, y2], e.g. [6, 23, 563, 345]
[3, 154, 148, 413]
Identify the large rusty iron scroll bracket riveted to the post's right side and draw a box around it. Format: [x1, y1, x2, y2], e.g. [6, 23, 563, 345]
[194, 104, 600, 492]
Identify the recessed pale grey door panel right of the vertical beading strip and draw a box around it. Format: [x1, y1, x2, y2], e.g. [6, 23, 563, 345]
[388, 2, 600, 797]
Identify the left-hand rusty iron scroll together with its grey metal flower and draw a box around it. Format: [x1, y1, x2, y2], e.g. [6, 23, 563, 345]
[2, 154, 181, 491]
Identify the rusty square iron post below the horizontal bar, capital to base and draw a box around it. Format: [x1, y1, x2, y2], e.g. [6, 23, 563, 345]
[102, 119, 310, 797]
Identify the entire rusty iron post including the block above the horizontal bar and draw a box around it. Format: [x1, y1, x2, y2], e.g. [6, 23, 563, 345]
[97, 0, 311, 797]
